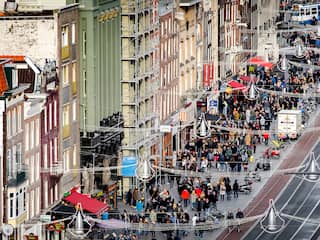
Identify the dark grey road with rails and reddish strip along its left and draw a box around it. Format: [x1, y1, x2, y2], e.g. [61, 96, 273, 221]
[217, 109, 320, 240]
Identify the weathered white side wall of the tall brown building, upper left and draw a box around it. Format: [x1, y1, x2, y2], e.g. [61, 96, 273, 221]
[0, 18, 57, 66]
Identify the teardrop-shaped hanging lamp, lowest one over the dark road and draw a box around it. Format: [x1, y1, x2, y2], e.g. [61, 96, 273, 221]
[260, 199, 285, 234]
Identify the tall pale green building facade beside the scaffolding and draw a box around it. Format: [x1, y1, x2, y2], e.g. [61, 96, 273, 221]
[79, 0, 121, 131]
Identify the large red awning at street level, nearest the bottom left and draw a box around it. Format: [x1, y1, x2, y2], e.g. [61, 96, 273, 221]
[64, 189, 110, 216]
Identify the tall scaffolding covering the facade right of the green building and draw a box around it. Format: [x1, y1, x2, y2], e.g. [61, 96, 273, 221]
[121, 0, 159, 156]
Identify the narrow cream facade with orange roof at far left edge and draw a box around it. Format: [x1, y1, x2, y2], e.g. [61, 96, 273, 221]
[0, 59, 28, 236]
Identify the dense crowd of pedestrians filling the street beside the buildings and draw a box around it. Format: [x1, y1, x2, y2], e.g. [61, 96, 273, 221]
[102, 36, 320, 240]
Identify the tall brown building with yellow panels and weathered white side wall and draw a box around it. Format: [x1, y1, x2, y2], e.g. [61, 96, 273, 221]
[0, 2, 80, 204]
